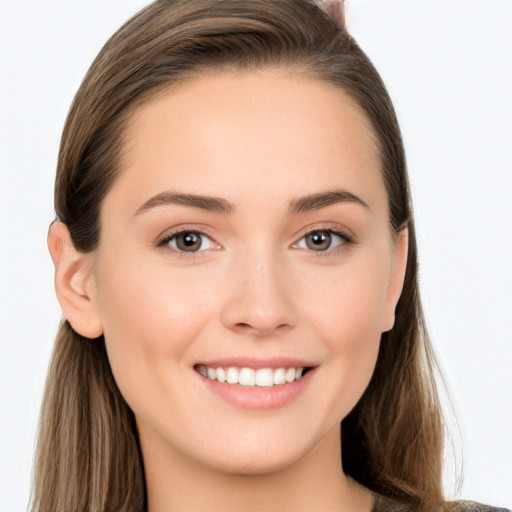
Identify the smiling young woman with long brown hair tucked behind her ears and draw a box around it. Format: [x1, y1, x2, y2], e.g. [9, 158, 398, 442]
[33, 0, 512, 511]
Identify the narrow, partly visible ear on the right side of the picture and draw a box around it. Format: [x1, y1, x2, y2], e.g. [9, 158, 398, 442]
[382, 227, 409, 332]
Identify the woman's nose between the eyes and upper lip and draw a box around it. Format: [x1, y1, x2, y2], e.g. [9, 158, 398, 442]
[221, 251, 297, 337]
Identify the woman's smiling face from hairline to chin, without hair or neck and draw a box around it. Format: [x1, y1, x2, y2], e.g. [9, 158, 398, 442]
[84, 72, 405, 472]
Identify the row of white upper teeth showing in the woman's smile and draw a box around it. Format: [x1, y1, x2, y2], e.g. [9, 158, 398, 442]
[196, 364, 304, 388]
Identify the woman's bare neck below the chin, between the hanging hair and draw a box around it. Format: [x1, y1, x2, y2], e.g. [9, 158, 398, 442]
[142, 429, 372, 512]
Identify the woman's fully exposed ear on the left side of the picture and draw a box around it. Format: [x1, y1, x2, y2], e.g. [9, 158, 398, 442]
[48, 222, 103, 338]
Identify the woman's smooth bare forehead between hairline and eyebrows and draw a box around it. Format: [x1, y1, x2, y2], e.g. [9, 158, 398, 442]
[111, 72, 384, 215]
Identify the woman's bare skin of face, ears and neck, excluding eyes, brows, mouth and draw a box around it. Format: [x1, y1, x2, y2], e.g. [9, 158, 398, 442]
[49, 72, 407, 512]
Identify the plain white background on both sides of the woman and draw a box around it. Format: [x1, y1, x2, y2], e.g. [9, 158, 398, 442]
[0, 0, 512, 512]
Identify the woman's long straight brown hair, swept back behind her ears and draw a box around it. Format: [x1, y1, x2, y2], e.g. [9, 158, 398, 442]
[32, 0, 444, 512]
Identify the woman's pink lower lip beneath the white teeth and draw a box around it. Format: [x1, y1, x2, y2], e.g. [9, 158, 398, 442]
[198, 369, 314, 411]
